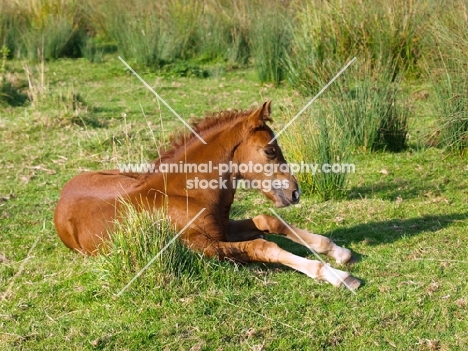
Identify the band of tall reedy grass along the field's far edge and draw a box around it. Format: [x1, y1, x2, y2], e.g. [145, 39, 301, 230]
[0, 0, 458, 86]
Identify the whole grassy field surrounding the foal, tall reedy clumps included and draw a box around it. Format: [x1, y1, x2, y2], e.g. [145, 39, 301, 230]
[0, 0, 468, 351]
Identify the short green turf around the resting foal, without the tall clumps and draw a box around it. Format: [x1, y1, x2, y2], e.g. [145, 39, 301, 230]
[0, 57, 468, 350]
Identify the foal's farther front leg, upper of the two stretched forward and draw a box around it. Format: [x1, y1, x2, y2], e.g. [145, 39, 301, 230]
[228, 215, 352, 263]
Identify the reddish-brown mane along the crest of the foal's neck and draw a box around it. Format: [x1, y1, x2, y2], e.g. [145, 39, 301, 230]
[159, 108, 266, 160]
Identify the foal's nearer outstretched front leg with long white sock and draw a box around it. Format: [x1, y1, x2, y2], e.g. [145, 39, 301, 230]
[188, 232, 361, 289]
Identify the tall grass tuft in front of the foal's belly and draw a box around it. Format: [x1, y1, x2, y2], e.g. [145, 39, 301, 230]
[100, 203, 203, 288]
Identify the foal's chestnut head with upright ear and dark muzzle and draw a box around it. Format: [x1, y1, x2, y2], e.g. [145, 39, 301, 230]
[233, 102, 300, 207]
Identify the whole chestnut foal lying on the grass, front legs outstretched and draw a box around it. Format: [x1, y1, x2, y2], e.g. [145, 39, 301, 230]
[55, 102, 360, 289]
